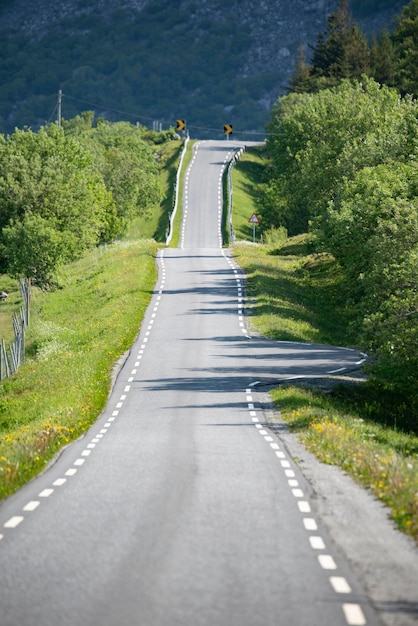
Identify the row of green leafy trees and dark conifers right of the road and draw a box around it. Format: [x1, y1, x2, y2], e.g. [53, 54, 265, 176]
[260, 0, 418, 420]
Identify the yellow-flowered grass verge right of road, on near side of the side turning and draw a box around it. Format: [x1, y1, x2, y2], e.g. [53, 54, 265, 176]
[272, 386, 418, 542]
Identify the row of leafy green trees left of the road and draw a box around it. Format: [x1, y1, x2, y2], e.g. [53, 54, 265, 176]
[0, 112, 172, 288]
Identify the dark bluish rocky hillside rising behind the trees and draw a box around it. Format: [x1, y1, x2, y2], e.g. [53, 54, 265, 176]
[0, 0, 406, 136]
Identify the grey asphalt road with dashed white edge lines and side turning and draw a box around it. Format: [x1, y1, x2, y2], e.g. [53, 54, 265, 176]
[0, 141, 381, 626]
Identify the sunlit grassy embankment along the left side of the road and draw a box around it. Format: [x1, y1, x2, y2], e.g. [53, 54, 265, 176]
[0, 135, 180, 499]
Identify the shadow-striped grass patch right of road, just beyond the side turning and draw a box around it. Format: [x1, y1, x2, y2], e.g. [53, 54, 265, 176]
[234, 235, 353, 345]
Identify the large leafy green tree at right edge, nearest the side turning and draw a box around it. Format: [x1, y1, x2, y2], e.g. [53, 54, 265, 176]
[324, 163, 418, 389]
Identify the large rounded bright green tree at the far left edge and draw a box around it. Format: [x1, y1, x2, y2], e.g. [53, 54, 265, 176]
[0, 125, 118, 282]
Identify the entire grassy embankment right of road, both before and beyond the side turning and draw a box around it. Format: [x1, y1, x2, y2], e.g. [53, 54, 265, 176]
[233, 144, 418, 541]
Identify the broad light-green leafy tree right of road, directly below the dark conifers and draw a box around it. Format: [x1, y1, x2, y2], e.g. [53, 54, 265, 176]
[266, 78, 418, 234]
